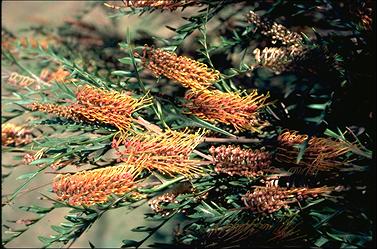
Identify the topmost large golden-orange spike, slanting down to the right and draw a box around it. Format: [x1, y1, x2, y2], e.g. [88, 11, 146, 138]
[142, 46, 220, 90]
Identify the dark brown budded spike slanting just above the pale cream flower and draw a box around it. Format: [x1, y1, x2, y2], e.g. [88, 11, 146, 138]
[247, 11, 303, 47]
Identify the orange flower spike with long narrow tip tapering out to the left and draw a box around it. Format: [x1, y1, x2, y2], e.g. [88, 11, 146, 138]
[30, 86, 150, 130]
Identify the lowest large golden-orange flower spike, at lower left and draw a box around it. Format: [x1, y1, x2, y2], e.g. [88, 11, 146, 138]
[52, 165, 134, 206]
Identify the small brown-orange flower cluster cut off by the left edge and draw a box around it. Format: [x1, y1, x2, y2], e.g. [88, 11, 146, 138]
[1, 123, 33, 146]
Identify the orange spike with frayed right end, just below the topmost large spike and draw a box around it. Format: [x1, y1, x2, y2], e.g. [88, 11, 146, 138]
[185, 90, 269, 132]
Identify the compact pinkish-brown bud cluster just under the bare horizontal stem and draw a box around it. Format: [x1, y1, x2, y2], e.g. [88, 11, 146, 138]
[209, 145, 271, 176]
